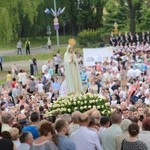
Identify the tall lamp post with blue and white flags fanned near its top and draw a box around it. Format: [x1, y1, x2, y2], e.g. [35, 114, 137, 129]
[44, 0, 65, 47]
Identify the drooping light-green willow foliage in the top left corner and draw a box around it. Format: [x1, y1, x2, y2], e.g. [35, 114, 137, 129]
[0, 0, 43, 42]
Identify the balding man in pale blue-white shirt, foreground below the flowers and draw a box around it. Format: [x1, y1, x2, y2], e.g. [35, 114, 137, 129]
[70, 114, 102, 150]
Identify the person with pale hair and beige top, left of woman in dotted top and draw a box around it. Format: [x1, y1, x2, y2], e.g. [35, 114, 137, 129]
[116, 119, 132, 150]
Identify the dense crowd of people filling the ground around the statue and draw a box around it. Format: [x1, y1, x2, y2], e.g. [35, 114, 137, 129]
[0, 38, 150, 150]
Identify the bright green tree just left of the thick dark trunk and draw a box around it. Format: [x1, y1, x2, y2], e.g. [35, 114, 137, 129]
[103, 0, 129, 32]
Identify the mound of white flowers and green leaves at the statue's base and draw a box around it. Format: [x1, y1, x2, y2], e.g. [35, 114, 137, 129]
[46, 93, 111, 116]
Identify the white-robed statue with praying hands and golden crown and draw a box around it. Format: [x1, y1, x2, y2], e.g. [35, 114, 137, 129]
[64, 39, 83, 96]
